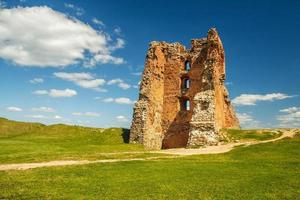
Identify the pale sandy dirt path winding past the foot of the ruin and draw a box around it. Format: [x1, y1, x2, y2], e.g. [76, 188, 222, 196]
[0, 130, 296, 171]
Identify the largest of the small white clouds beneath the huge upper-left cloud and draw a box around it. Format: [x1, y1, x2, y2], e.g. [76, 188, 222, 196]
[54, 72, 106, 92]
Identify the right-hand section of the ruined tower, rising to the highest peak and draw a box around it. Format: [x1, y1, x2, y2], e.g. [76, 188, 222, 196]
[187, 29, 239, 147]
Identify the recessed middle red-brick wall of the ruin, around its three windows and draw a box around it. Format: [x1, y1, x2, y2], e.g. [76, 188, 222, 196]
[162, 40, 204, 148]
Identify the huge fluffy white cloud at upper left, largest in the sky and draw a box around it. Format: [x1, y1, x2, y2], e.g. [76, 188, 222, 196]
[0, 6, 124, 67]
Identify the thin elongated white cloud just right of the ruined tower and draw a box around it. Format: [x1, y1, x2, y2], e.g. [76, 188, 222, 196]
[232, 93, 293, 106]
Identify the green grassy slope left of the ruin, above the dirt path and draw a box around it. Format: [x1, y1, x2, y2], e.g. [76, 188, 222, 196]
[0, 118, 143, 163]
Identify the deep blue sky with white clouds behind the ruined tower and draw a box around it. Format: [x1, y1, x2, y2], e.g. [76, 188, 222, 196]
[0, 0, 300, 128]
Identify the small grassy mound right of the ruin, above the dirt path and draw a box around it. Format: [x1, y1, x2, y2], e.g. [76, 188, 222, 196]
[222, 129, 282, 141]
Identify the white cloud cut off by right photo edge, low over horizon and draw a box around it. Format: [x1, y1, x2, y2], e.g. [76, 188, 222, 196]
[276, 107, 300, 128]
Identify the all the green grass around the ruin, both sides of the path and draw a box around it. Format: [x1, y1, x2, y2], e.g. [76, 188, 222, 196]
[0, 119, 300, 200]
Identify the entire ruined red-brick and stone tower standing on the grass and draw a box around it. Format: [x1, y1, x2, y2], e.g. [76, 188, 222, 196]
[130, 29, 239, 149]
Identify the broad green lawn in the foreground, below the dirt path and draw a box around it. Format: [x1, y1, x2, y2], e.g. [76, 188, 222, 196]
[0, 135, 300, 199]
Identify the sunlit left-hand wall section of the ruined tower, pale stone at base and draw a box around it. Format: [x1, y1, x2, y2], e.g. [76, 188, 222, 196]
[130, 42, 166, 149]
